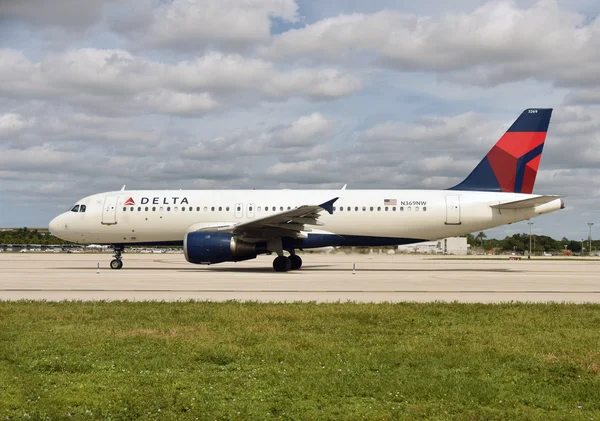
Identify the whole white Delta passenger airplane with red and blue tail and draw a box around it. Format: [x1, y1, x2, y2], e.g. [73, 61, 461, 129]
[49, 109, 564, 272]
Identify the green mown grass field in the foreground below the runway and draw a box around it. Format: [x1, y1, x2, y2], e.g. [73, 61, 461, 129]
[0, 302, 600, 420]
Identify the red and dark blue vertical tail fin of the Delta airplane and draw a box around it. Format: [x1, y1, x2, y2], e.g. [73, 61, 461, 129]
[450, 108, 552, 194]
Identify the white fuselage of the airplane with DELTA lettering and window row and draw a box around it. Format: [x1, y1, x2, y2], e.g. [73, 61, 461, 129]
[50, 190, 562, 245]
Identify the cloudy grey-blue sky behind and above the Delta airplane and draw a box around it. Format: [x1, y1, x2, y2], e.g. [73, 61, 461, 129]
[0, 0, 600, 239]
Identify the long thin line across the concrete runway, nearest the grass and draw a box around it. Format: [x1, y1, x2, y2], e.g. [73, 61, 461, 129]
[0, 288, 600, 294]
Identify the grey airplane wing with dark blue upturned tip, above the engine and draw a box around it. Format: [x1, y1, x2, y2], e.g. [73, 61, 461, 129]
[197, 197, 338, 241]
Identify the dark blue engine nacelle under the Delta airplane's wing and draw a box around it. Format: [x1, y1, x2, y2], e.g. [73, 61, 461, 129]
[183, 231, 258, 265]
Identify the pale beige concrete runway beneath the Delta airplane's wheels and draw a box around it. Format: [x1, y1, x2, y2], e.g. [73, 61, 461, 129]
[0, 253, 600, 303]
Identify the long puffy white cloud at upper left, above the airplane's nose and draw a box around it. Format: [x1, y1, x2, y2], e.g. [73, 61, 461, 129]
[0, 48, 361, 116]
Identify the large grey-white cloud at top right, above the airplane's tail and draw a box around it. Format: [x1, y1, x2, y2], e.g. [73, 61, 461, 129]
[262, 0, 600, 90]
